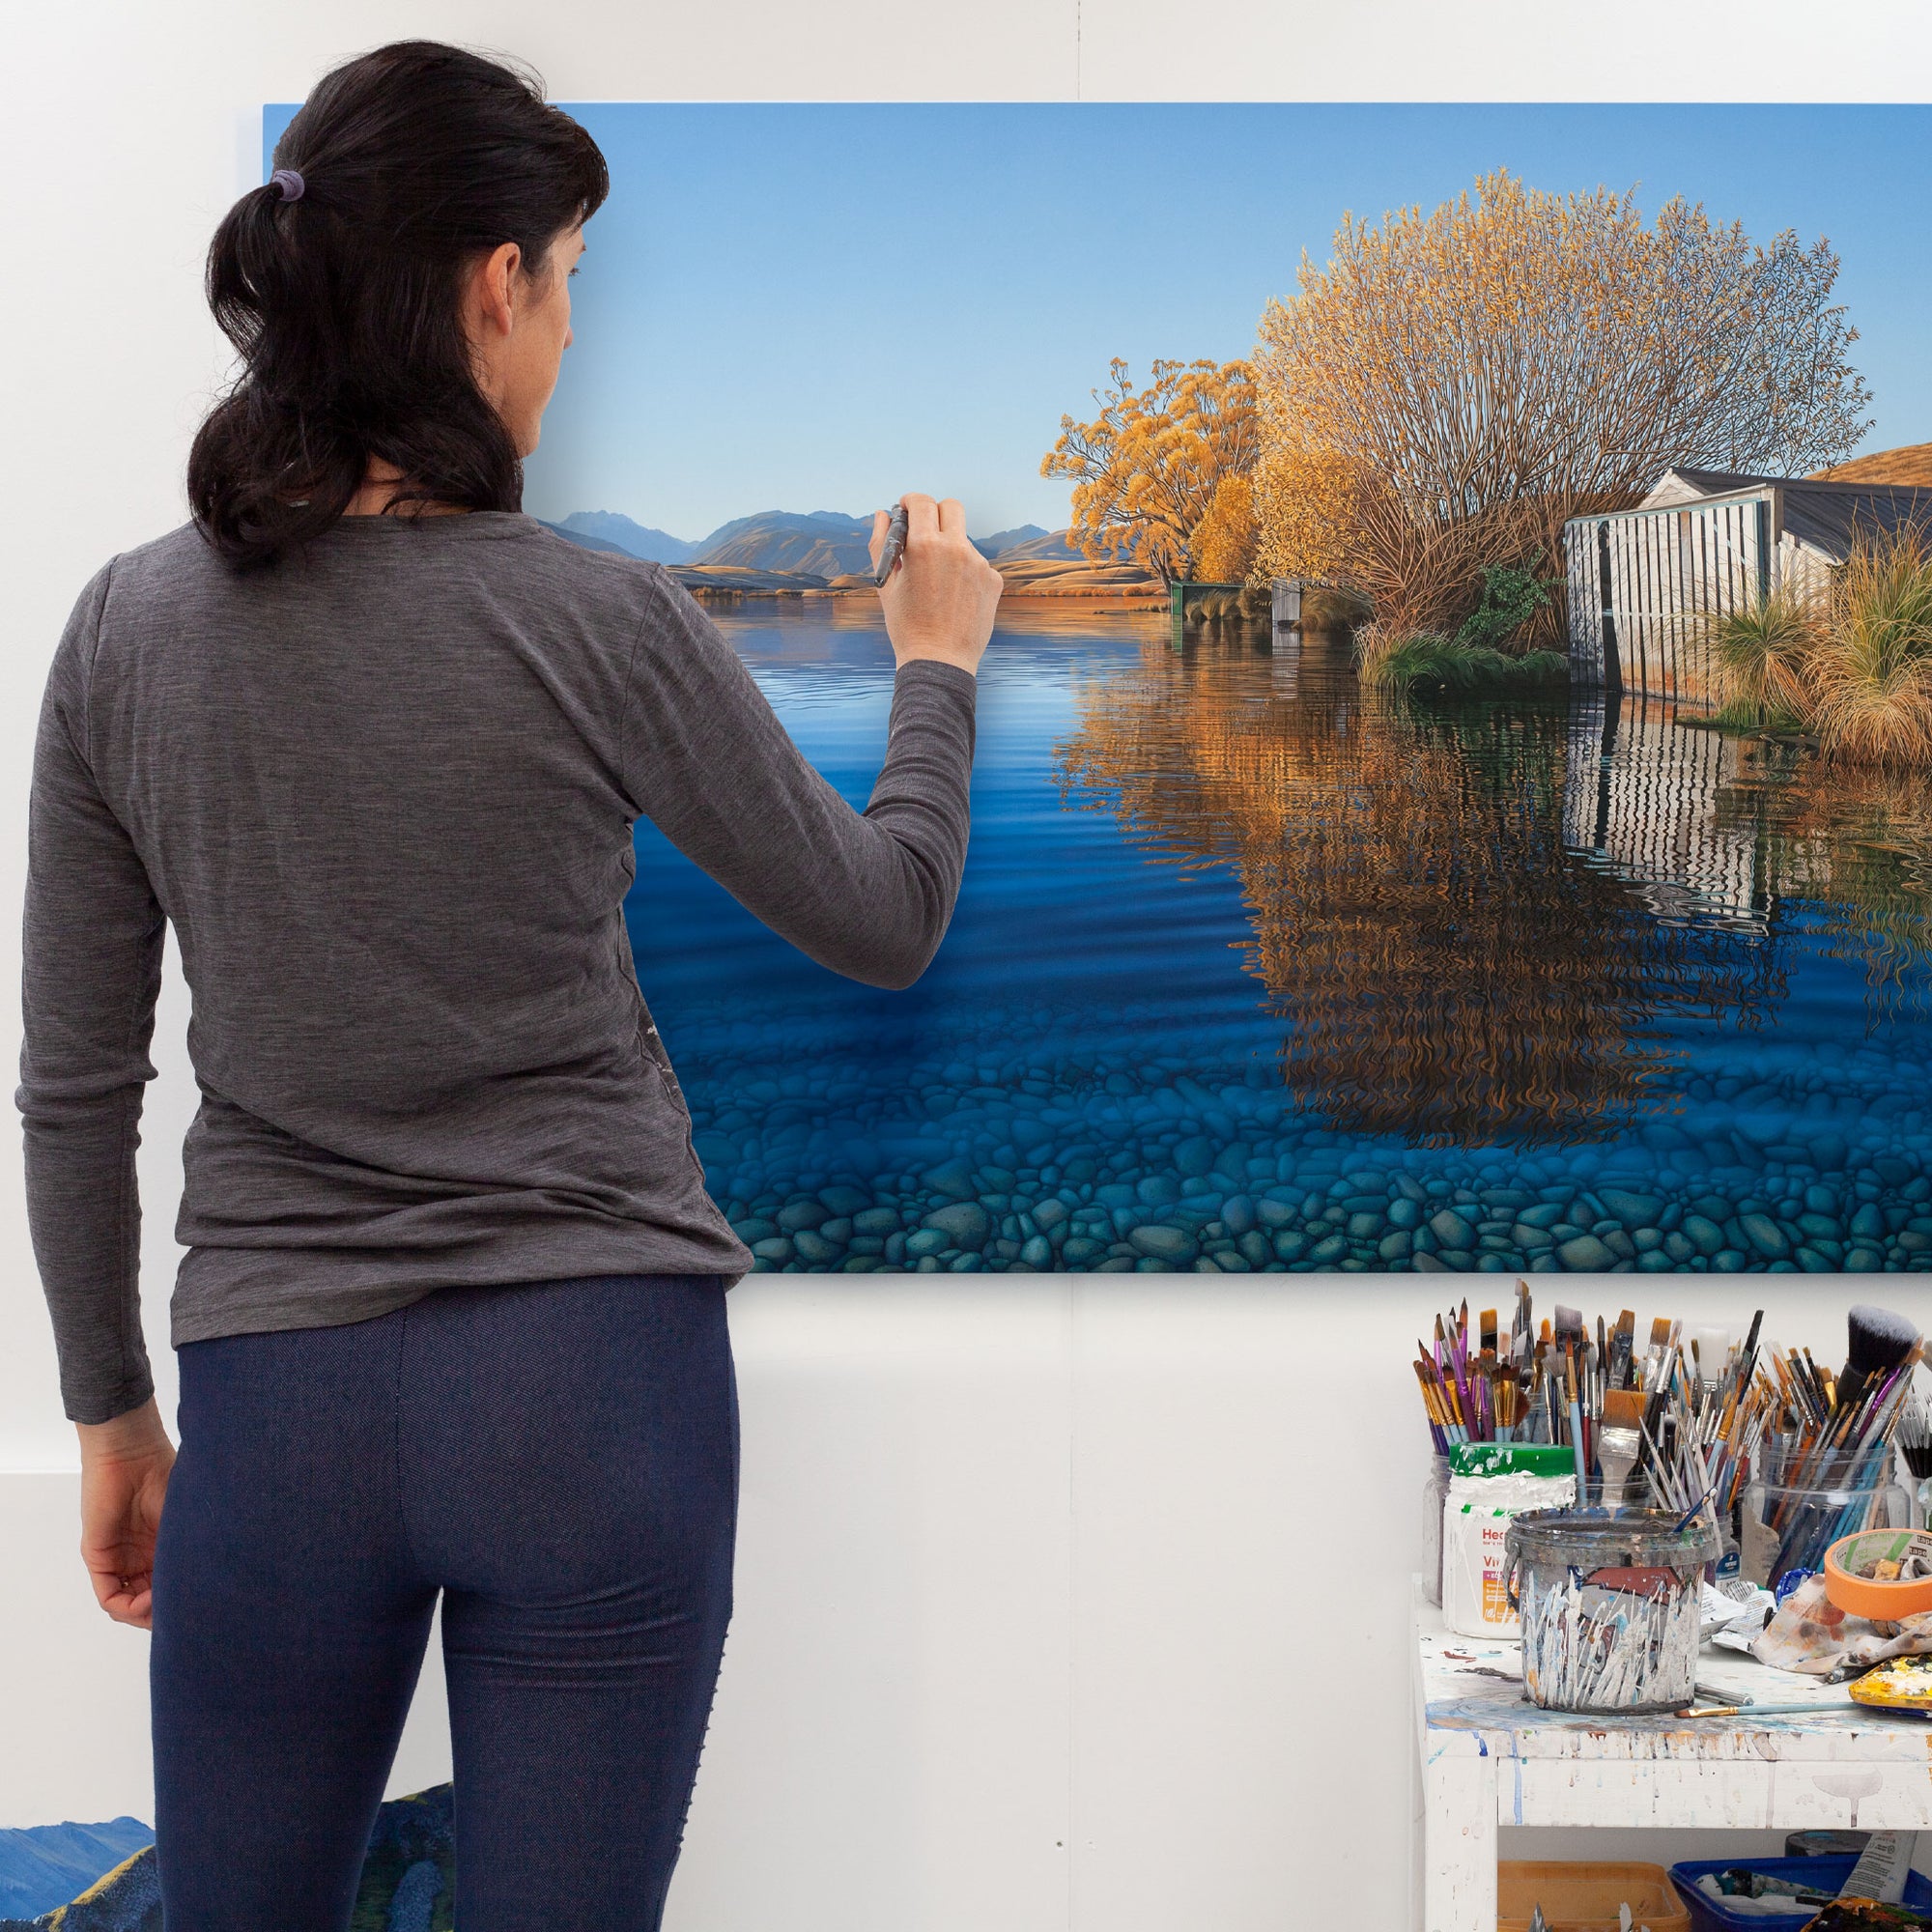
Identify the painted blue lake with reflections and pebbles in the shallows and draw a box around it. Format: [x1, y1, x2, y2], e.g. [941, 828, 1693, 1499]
[632, 601, 1932, 1271]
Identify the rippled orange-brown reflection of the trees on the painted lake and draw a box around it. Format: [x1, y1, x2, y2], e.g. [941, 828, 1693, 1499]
[1057, 643, 1779, 1144]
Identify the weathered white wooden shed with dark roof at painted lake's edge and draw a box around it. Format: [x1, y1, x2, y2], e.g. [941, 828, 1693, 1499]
[1563, 469, 1932, 703]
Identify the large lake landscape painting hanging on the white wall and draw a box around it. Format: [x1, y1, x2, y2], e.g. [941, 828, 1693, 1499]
[267, 104, 1932, 1273]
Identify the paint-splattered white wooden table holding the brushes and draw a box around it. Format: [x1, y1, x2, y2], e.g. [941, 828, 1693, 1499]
[1412, 1580, 1932, 1932]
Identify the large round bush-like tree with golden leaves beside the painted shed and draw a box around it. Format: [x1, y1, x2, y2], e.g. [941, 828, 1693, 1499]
[1254, 170, 1870, 624]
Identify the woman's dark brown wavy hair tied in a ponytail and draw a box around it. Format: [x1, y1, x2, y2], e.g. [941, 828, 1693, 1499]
[187, 41, 611, 566]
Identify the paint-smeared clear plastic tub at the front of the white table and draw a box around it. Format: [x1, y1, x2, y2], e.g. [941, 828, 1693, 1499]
[1509, 1509, 1723, 1718]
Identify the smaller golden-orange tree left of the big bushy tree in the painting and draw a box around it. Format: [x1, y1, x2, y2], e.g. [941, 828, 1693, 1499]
[1039, 355, 1256, 583]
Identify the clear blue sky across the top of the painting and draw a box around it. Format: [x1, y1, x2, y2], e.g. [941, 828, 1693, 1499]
[265, 104, 1932, 537]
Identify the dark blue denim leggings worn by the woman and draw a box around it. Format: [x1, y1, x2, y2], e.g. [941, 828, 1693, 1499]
[151, 1275, 738, 1932]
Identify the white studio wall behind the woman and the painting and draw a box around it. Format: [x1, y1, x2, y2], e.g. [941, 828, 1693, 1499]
[0, 0, 1932, 1932]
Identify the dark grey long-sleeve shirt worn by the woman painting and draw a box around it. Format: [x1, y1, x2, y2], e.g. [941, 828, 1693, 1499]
[17, 512, 976, 1422]
